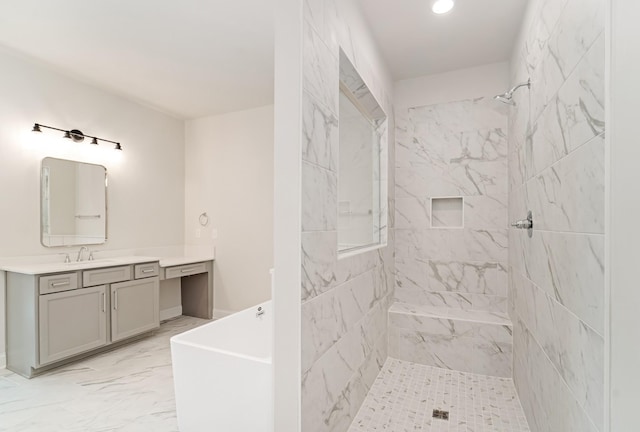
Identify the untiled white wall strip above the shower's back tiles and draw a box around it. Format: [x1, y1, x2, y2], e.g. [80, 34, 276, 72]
[394, 62, 509, 110]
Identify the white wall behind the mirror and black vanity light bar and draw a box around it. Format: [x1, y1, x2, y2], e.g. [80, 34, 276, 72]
[0, 46, 184, 362]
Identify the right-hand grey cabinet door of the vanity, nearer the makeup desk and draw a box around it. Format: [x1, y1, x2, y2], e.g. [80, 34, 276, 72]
[111, 277, 160, 342]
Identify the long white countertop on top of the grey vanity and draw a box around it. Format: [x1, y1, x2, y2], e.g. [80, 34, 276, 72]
[0, 255, 213, 275]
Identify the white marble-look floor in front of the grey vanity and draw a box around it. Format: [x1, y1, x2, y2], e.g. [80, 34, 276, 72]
[0, 316, 209, 432]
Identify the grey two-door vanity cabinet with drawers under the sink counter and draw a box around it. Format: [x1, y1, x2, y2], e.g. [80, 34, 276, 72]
[6, 262, 160, 378]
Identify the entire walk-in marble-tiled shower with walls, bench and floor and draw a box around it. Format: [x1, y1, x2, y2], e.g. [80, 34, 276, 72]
[301, 0, 605, 432]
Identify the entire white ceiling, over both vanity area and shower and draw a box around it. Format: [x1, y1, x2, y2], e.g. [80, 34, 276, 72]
[0, 0, 527, 118]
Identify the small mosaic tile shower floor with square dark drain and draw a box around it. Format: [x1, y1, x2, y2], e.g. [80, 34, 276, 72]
[349, 358, 529, 432]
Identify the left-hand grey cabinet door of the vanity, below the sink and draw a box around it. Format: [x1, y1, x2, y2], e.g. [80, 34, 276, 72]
[39, 285, 107, 365]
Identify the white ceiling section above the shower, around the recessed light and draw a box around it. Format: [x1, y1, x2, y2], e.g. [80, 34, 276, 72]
[358, 0, 527, 80]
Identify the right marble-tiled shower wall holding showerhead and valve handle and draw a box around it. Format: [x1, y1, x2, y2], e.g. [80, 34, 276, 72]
[507, 0, 606, 432]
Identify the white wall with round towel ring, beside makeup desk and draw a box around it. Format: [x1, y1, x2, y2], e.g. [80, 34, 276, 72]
[185, 106, 273, 314]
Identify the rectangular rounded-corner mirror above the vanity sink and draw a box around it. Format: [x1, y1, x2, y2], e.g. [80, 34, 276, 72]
[40, 158, 107, 247]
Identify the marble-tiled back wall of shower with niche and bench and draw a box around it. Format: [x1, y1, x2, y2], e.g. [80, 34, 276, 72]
[389, 98, 512, 377]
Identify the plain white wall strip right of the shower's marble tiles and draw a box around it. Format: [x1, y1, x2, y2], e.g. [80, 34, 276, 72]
[605, 0, 640, 432]
